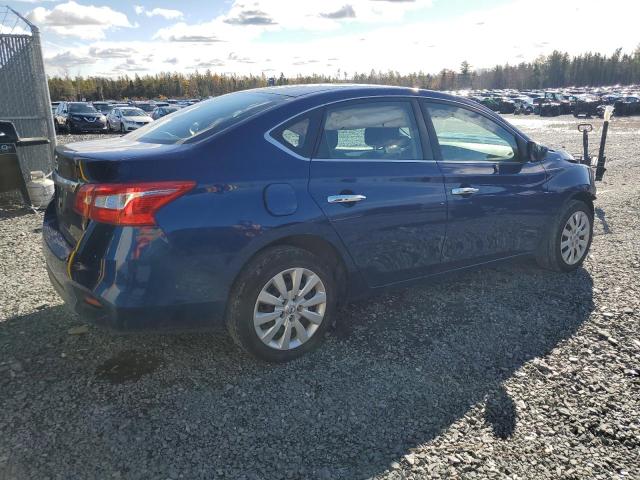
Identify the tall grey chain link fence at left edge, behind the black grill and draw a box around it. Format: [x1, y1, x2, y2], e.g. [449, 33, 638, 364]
[0, 6, 55, 204]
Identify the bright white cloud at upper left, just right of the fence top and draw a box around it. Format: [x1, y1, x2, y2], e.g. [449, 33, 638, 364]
[27, 0, 133, 40]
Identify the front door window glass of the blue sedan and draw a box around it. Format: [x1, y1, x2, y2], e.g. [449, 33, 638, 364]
[427, 103, 518, 162]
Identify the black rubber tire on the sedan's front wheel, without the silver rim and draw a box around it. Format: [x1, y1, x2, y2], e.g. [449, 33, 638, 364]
[536, 200, 593, 272]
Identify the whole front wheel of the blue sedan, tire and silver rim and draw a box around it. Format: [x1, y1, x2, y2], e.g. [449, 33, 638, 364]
[537, 200, 593, 272]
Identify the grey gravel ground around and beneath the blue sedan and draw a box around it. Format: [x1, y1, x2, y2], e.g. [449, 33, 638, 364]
[0, 117, 640, 480]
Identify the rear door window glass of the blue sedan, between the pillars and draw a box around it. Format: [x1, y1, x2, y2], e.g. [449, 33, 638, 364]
[317, 101, 422, 160]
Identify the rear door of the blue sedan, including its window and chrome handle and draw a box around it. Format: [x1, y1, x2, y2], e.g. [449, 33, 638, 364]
[309, 97, 447, 287]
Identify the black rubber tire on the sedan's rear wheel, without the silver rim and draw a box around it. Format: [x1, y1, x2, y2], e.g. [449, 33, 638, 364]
[226, 245, 338, 363]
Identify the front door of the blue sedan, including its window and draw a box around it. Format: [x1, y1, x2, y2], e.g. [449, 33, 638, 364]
[423, 101, 551, 267]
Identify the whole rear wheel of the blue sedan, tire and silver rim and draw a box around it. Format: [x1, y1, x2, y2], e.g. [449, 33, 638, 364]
[226, 246, 336, 362]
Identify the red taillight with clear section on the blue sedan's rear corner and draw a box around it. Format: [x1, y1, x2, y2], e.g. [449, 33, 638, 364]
[74, 182, 195, 225]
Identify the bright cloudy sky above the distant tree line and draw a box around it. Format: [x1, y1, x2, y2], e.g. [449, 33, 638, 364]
[0, 0, 640, 77]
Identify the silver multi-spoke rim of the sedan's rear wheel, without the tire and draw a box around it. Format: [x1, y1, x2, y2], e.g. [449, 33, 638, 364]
[253, 268, 327, 350]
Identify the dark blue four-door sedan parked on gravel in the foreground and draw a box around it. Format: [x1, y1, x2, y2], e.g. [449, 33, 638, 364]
[43, 85, 595, 361]
